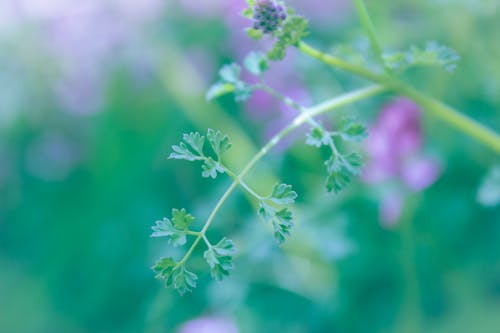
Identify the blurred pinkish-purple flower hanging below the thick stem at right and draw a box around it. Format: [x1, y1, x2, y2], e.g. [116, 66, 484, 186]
[363, 98, 440, 225]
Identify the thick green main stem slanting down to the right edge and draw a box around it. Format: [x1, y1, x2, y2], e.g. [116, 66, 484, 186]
[298, 42, 500, 153]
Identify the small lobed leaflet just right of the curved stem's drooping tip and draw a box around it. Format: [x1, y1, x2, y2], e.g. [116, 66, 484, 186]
[203, 237, 236, 281]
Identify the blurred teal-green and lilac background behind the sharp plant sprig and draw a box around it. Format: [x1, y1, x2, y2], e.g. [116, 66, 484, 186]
[0, 0, 500, 333]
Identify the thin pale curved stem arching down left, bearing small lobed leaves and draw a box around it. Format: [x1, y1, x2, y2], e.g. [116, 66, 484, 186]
[176, 85, 385, 267]
